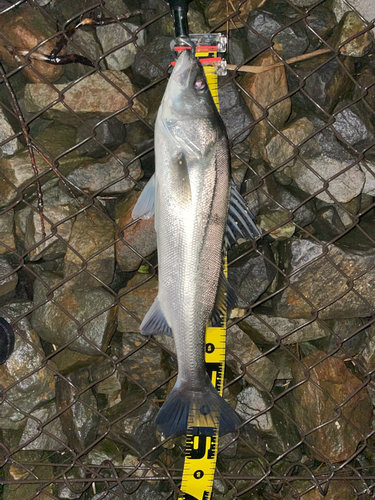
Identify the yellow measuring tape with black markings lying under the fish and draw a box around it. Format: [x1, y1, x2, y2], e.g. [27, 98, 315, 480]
[176, 38, 227, 500]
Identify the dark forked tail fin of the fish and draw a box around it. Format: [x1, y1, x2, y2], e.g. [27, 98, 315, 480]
[155, 378, 241, 437]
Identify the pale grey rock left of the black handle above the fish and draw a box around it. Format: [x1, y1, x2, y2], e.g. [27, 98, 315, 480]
[96, 21, 145, 71]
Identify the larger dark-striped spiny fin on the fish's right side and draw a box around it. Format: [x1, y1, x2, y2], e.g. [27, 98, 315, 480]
[225, 182, 261, 247]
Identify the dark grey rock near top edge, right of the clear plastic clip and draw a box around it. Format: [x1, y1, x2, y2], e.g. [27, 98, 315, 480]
[247, 7, 309, 59]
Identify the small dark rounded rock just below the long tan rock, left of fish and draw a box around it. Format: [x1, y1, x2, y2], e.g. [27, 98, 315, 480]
[77, 116, 126, 158]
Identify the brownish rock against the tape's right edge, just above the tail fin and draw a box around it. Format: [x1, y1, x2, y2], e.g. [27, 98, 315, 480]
[226, 325, 278, 391]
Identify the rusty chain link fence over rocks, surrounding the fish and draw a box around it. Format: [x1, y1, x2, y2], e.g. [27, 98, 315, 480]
[0, 0, 375, 500]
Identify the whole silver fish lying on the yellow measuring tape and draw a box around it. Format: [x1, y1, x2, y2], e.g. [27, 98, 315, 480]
[132, 50, 260, 437]
